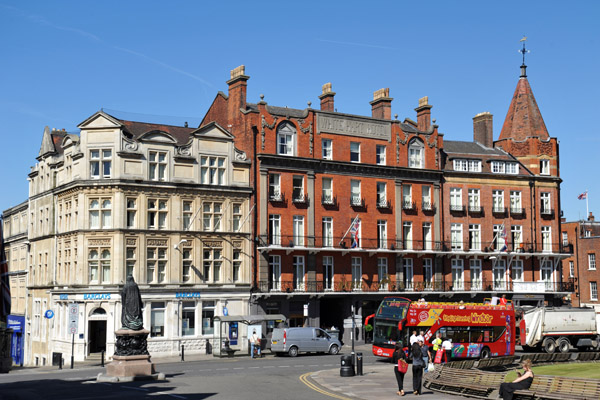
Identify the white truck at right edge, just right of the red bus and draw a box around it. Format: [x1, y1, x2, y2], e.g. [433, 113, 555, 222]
[517, 307, 600, 353]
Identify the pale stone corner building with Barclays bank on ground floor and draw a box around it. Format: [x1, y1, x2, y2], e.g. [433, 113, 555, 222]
[9, 111, 252, 365]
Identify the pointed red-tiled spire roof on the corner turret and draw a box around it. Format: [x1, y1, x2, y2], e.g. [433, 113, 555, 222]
[499, 64, 550, 141]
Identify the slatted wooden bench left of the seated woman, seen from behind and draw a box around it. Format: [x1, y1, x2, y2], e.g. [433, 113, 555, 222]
[424, 365, 506, 399]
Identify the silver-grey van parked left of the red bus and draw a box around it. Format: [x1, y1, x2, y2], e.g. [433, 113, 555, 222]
[271, 328, 342, 357]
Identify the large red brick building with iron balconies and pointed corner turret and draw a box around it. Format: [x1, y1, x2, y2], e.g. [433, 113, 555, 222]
[202, 60, 569, 334]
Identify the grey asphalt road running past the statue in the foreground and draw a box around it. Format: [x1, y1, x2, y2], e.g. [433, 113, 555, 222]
[0, 355, 368, 400]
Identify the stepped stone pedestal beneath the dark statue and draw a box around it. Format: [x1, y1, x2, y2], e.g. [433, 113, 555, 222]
[97, 329, 165, 382]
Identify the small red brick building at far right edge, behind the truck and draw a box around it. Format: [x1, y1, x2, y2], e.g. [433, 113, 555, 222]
[562, 212, 600, 311]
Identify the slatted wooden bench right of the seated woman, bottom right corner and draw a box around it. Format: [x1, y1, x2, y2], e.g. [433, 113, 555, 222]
[515, 375, 600, 400]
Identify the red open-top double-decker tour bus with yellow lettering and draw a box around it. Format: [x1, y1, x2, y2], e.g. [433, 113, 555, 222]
[365, 297, 515, 359]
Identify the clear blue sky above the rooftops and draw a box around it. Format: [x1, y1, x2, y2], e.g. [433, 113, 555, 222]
[0, 0, 600, 220]
